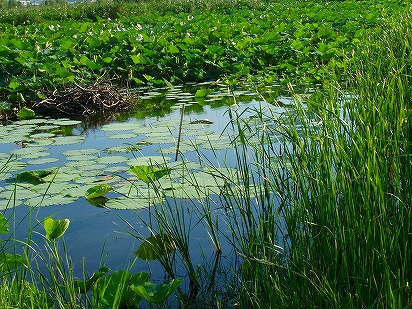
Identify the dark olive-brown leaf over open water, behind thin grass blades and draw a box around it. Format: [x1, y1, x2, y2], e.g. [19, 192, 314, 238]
[136, 234, 176, 260]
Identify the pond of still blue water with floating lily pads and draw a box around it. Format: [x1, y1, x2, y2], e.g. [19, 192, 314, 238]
[0, 82, 293, 288]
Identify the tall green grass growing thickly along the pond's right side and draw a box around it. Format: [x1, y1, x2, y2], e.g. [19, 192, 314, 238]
[212, 7, 412, 308]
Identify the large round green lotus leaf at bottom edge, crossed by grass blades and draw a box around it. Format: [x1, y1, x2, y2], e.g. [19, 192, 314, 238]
[92, 270, 149, 308]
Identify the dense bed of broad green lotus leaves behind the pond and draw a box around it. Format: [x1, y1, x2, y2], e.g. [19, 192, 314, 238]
[0, 1, 404, 119]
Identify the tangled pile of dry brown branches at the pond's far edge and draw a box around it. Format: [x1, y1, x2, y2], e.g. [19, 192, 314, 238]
[33, 82, 132, 116]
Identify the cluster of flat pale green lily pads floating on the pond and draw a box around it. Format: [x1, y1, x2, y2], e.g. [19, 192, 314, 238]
[0, 84, 290, 209]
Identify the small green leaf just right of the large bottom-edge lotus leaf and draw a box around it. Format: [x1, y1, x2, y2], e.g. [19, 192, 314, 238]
[130, 279, 183, 304]
